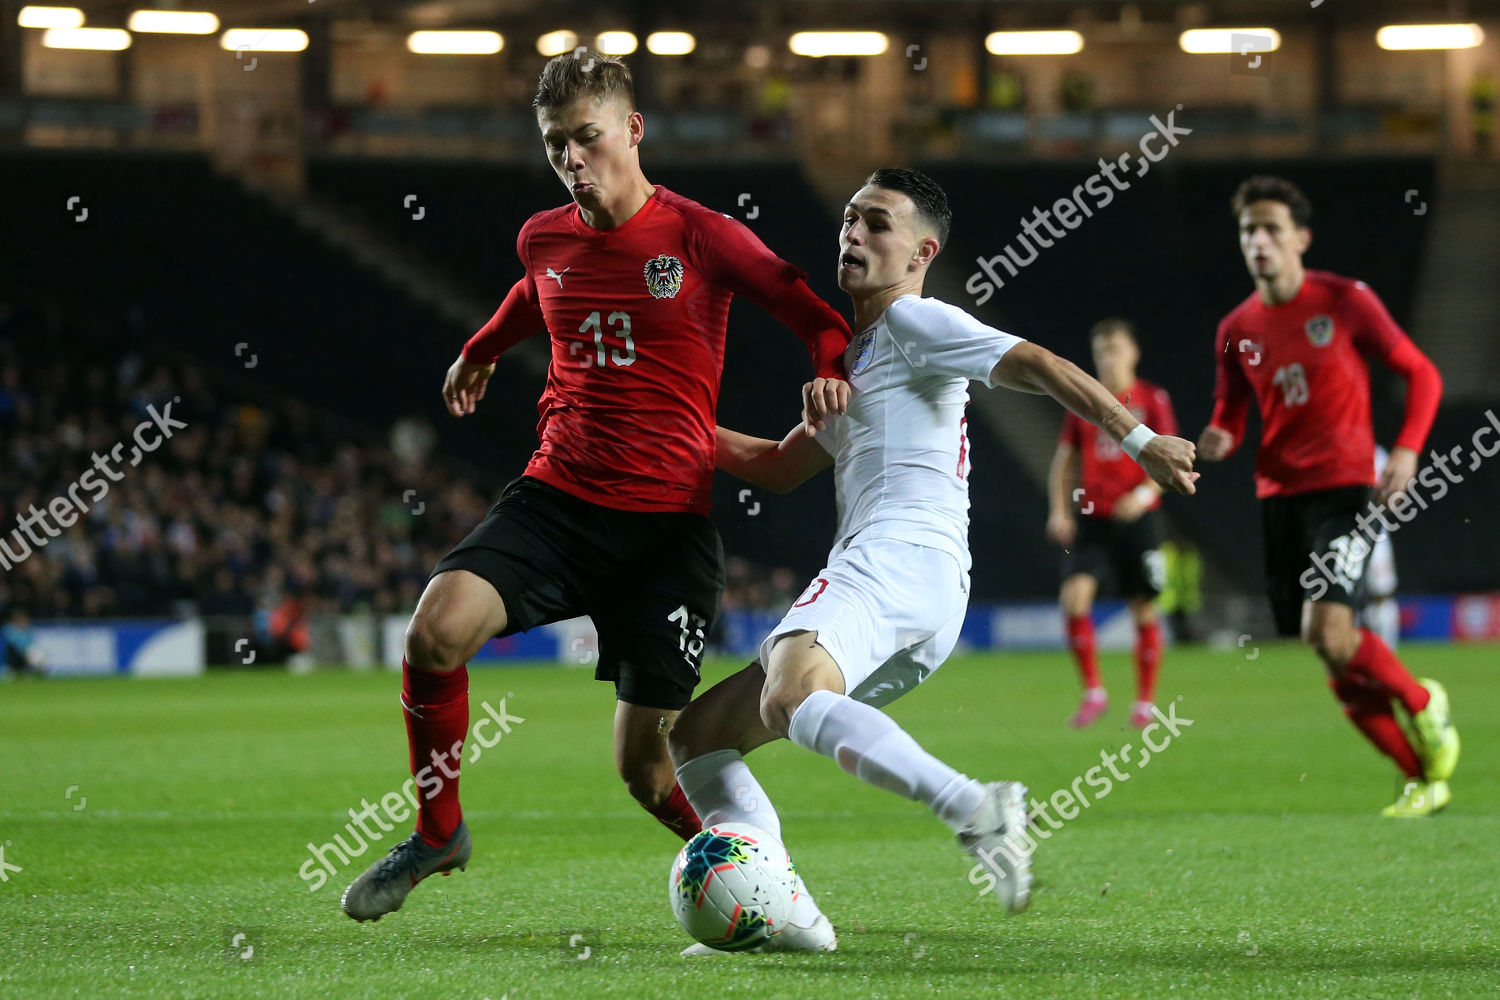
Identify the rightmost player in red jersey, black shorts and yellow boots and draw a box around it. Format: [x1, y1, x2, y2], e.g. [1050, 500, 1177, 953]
[1199, 177, 1458, 817]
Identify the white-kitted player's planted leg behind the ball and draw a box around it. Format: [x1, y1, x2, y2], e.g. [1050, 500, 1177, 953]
[668, 661, 839, 955]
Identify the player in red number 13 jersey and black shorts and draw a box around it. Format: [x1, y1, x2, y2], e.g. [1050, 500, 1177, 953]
[342, 49, 849, 921]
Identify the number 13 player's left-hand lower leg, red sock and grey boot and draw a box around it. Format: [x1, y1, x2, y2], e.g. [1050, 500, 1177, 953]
[341, 570, 506, 921]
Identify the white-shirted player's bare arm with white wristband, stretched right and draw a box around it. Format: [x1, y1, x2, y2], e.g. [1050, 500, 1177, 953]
[990, 340, 1199, 495]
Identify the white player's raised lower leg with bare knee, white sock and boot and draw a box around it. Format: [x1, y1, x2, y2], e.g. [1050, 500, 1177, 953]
[761, 631, 1032, 912]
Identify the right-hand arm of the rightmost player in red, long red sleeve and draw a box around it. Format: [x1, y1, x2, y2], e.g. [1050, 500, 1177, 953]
[1350, 282, 1443, 504]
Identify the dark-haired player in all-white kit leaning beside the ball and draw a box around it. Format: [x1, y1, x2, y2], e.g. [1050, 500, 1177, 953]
[669, 169, 1197, 954]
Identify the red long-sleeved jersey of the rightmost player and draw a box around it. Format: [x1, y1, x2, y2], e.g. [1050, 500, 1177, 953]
[1209, 271, 1443, 496]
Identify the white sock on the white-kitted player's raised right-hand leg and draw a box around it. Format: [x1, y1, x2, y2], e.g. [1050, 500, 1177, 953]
[786, 691, 986, 831]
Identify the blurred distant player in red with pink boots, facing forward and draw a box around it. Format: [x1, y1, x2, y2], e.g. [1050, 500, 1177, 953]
[1047, 318, 1178, 729]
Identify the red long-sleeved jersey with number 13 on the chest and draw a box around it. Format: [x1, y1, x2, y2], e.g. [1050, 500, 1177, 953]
[464, 186, 851, 513]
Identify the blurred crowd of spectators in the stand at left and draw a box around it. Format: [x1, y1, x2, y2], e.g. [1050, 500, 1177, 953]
[0, 303, 491, 621]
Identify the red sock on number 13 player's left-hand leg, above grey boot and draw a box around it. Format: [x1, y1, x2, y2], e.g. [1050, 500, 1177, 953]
[401, 657, 468, 847]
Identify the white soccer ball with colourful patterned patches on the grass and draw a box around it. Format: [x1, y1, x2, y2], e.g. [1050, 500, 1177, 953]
[668, 823, 797, 952]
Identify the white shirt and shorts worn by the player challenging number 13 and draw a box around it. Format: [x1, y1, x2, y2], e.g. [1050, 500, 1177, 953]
[761, 295, 1022, 706]
